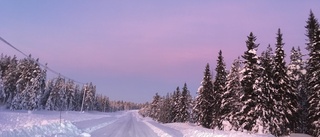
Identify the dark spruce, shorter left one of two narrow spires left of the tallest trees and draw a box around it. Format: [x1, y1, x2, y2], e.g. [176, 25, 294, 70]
[194, 64, 214, 128]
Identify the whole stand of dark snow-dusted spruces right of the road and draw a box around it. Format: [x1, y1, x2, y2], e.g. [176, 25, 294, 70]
[141, 11, 320, 137]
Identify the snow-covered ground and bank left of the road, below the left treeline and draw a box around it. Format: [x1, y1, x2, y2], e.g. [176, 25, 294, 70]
[0, 109, 108, 137]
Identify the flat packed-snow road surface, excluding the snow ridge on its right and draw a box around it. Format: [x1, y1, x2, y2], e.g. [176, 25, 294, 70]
[74, 111, 158, 137]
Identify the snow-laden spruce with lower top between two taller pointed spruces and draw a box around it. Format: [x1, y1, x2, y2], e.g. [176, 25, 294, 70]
[253, 45, 277, 133]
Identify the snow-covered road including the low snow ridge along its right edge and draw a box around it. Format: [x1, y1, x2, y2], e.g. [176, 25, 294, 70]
[74, 111, 183, 137]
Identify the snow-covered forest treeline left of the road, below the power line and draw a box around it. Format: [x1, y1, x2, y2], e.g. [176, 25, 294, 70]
[0, 54, 142, 112]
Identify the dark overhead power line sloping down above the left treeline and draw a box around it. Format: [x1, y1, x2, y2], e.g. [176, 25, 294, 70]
[0, 36, 85, 85]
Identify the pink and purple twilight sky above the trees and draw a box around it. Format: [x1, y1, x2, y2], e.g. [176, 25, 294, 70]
[0, 0, 320, 102]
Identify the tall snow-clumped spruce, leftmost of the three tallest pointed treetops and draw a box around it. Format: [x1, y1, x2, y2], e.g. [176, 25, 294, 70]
[235, 32, 259, 131]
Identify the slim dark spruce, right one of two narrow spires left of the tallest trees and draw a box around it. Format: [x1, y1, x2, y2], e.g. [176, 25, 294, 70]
[212, 50, 227, 128]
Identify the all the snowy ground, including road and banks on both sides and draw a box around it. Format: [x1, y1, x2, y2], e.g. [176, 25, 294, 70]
[0, 110, 310, 137]
